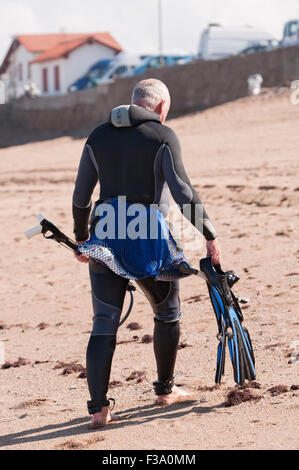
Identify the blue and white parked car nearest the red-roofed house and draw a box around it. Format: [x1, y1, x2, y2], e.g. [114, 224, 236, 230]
[68, 55, 140, 93]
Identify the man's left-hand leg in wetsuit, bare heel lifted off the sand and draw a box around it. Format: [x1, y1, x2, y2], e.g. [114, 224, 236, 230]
[86, 261, 128, 428]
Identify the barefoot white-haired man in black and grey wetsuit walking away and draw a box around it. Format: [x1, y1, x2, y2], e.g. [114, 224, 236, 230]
[73, 79, 220, 429]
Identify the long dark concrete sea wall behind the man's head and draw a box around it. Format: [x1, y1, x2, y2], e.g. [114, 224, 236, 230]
[0, 46, 299, 146]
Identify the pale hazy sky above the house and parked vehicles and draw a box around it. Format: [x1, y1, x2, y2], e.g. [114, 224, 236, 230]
[0, 0, 299, 61]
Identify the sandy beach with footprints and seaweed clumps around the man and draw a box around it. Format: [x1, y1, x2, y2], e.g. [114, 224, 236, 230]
[0, 89, 299, 450]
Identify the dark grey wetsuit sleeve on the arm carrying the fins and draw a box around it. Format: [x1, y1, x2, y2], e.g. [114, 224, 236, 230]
[162, 129, 216, 240]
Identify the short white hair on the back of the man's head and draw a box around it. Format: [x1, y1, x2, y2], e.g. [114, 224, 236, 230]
[132, 78, 170, 111]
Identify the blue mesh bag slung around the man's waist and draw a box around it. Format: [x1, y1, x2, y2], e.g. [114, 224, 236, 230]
[79, 199, 190, 281]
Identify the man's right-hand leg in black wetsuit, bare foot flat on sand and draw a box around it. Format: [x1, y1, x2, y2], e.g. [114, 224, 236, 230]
[138, 278, 190, 405]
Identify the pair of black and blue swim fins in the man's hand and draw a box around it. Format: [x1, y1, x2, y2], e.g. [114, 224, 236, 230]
[200, 257, 256, 385]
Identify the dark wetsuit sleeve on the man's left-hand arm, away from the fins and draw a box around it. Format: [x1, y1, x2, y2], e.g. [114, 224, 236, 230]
[73, 145, 98, 241]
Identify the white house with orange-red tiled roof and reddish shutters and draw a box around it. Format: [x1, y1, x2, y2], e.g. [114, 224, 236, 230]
[0, 32, 122, 99]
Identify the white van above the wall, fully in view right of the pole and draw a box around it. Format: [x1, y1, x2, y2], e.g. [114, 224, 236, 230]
[198, 23, 275, 60]
